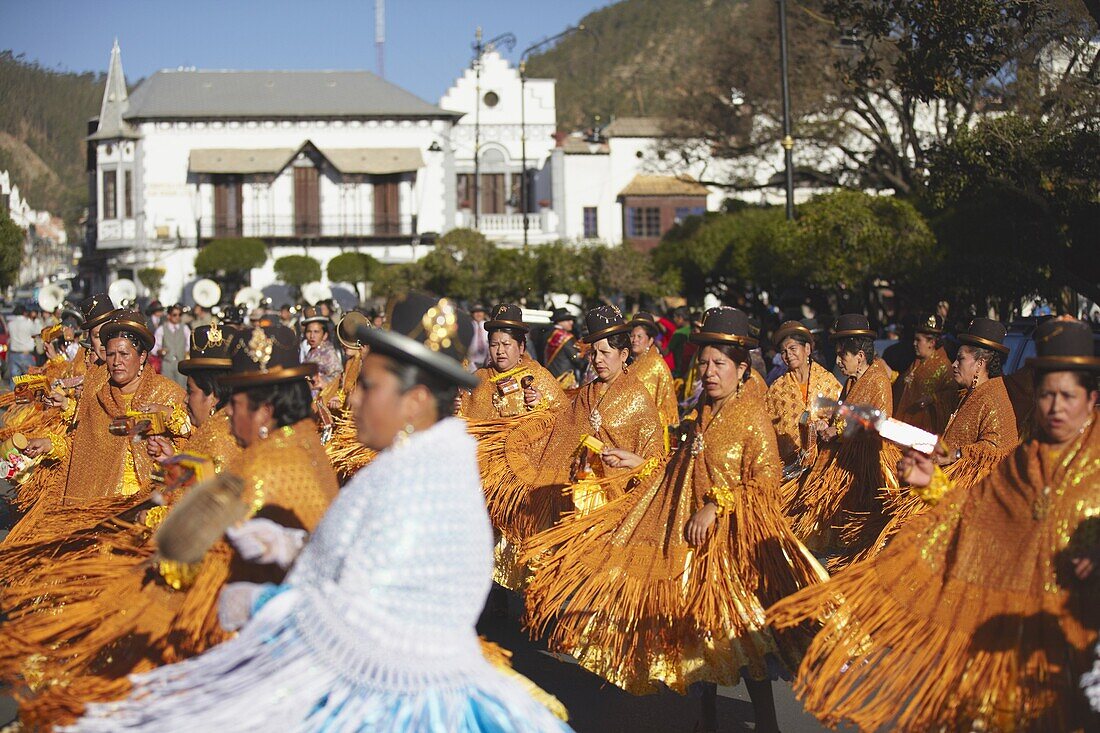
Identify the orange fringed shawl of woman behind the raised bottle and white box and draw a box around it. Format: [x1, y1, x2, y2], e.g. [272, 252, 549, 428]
[782, 359, 901, 553]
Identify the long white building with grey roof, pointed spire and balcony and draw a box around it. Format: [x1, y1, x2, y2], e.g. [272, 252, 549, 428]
[83, 44, 460, 302]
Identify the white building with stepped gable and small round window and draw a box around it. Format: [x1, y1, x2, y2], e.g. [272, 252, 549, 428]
[439, 51, 560, 243]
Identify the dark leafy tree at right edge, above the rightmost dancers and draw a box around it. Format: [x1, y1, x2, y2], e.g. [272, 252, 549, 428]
[925, 114, 1100, 310]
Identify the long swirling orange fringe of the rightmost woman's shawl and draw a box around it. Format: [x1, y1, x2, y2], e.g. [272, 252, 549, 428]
[768, 526, 1095, 733]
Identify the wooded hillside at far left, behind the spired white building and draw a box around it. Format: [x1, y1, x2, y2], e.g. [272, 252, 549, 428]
[0, 51, 105, 234]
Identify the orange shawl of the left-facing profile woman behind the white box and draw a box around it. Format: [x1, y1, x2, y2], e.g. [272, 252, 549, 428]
[865, 376, 1020, 557]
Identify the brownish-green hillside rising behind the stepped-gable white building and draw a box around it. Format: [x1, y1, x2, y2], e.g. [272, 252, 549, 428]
[527, 0, 741, 130]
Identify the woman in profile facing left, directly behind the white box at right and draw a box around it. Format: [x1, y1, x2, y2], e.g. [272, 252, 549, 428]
[870, 318, 1020, 553]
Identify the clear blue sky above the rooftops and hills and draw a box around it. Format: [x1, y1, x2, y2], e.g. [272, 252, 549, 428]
[0, 0, 611, 102]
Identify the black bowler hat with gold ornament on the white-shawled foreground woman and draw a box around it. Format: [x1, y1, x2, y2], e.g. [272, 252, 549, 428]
[356, 293, 479, 389]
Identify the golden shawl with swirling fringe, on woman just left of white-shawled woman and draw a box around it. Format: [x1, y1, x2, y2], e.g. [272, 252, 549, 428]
[0, 419, 337, 723]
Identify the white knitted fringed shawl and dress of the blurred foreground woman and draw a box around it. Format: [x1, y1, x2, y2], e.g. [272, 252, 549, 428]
[69, 418, 569, 733]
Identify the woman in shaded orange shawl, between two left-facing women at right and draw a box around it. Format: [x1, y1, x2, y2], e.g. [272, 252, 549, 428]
[893, 314, 957, 435]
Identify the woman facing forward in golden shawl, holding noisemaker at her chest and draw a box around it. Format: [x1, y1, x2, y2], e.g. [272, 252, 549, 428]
[458, 303, 565, 420]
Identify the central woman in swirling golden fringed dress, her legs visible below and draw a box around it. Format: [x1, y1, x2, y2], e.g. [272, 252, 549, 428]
[526, 307, 825, 731]
